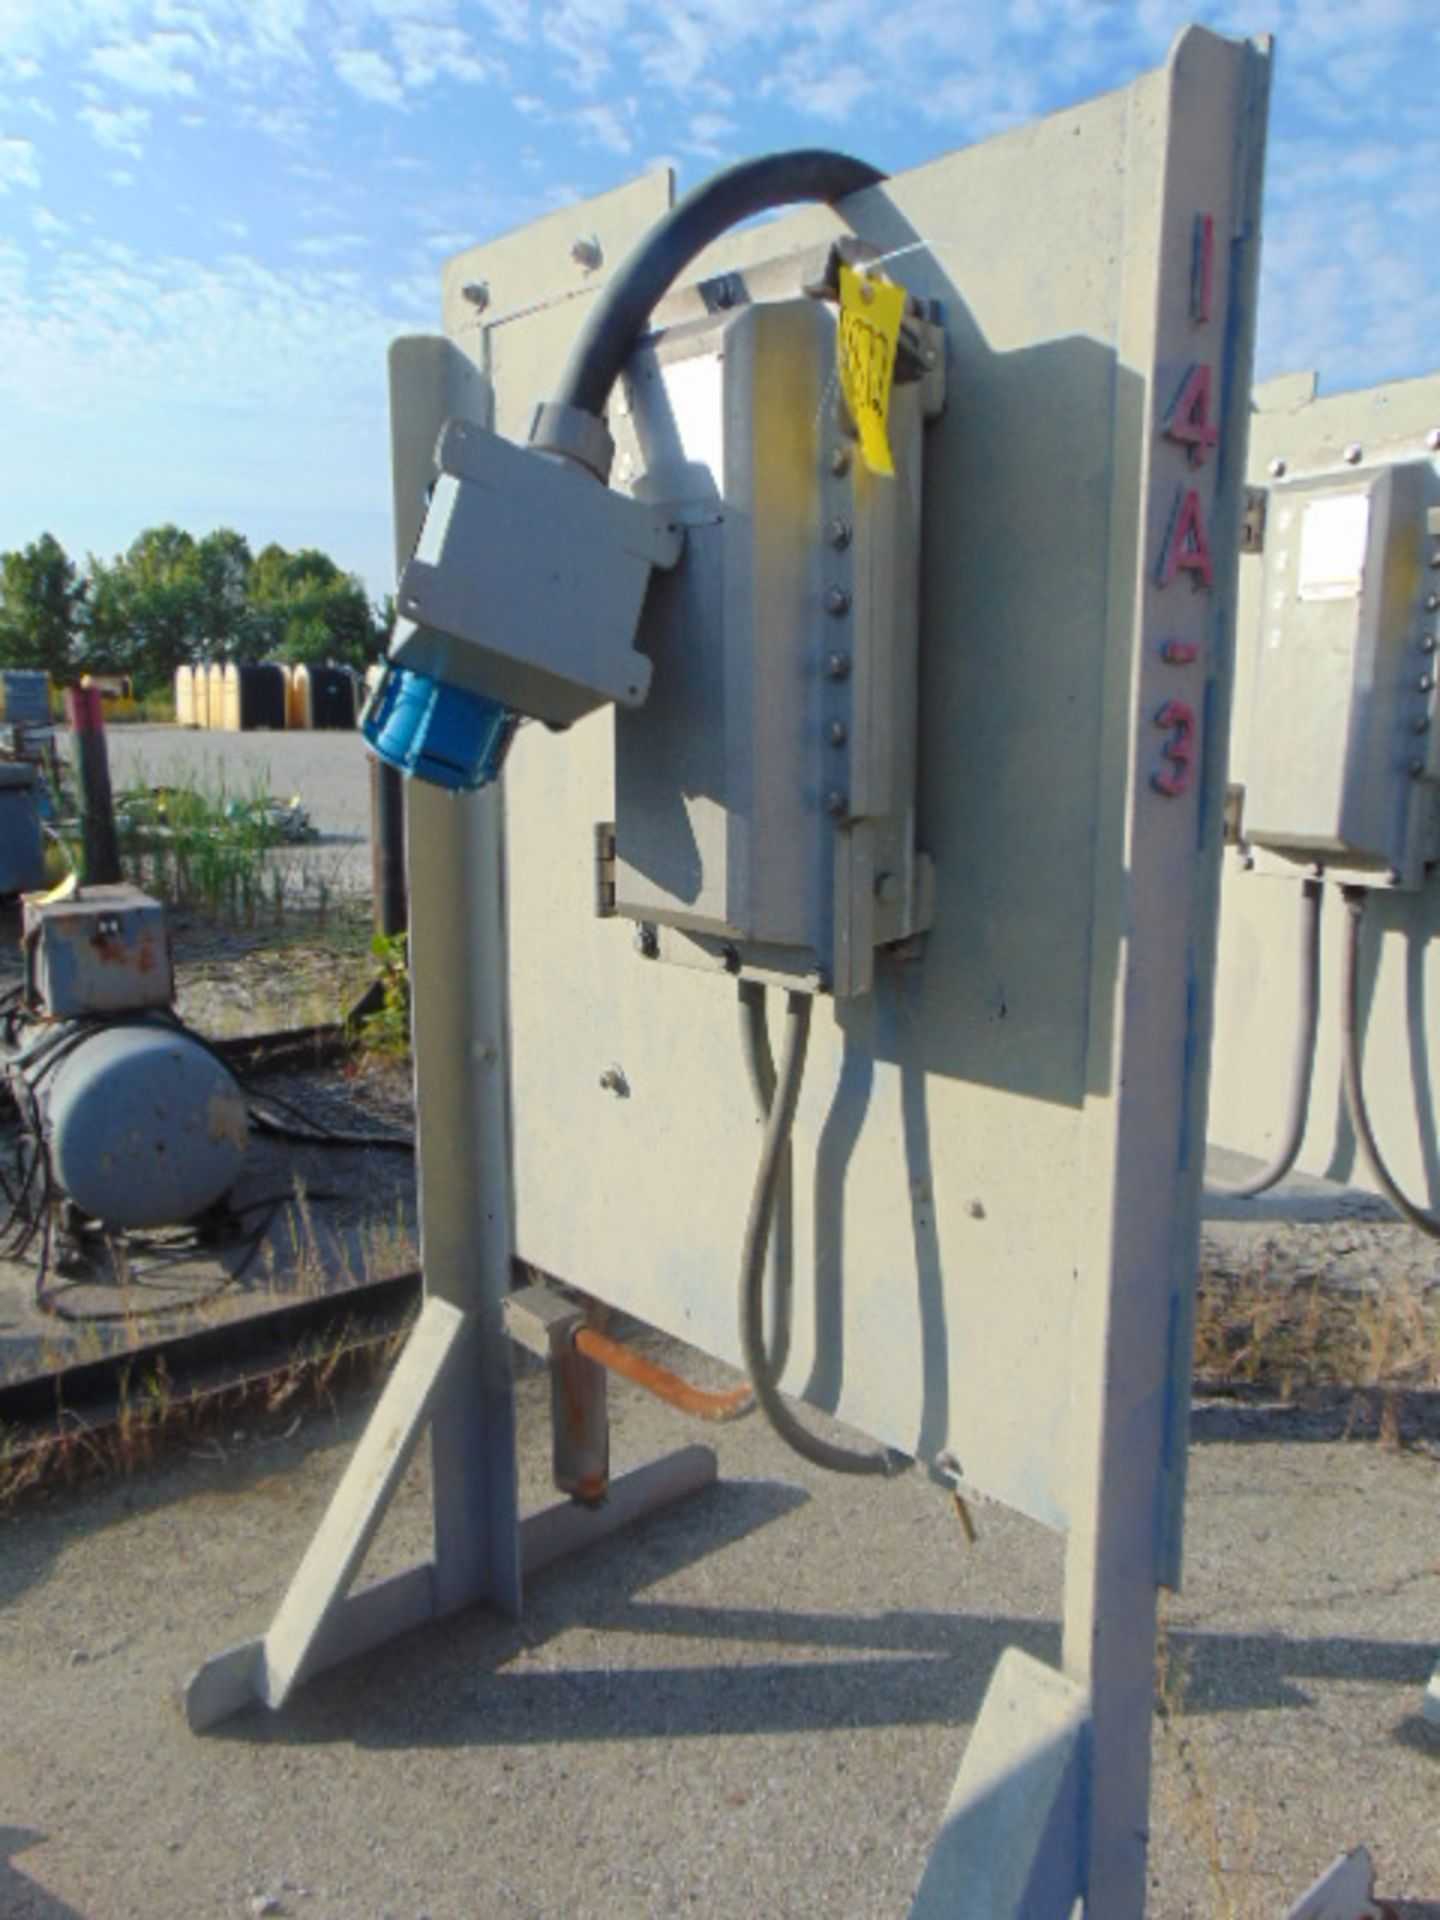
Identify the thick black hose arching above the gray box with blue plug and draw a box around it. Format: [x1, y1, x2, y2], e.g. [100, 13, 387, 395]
[537, 148, 885, 433]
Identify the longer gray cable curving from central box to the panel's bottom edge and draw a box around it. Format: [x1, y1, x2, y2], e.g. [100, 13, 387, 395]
[739, 989, 910, 1478]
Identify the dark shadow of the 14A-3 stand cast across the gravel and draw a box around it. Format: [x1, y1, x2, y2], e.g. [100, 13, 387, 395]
[200, 1480, 1440, 1751]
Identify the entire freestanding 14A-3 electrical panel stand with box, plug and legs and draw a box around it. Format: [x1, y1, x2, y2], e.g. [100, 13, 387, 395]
[188, 29, 1269, 1920]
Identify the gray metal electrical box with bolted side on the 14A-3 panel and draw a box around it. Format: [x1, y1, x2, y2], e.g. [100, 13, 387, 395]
[614, 298, 943, 996]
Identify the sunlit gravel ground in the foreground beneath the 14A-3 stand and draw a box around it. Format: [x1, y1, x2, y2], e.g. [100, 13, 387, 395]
[0, 1336, 1440, 1920]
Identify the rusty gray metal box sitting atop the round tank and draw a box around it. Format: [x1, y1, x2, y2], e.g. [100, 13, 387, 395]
[21, 885, 175, 1020]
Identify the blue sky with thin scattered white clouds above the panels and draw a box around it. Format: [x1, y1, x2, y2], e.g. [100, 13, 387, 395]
[0, 0, 1440, 597]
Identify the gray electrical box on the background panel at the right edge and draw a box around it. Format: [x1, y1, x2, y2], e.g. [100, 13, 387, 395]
[1244, 461, 1440, 885]
